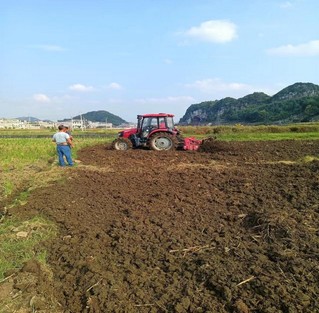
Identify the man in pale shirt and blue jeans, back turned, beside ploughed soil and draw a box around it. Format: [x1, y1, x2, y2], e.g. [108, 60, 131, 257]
[52, 125, 73, 167]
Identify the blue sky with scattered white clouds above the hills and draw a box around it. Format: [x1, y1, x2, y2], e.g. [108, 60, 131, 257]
[0, 0, 319, 121]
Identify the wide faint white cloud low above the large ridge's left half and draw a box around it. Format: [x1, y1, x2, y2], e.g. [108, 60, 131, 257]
[185, 78, 253, 93]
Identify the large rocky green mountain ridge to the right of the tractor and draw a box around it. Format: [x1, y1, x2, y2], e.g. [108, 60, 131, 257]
[179, 82, 319, 125]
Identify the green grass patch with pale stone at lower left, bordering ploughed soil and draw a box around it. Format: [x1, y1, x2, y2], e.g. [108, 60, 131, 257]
[0, 216, 57, 280]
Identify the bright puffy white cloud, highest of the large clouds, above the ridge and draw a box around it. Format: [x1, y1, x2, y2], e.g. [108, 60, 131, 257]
[184, 20, 237, 43]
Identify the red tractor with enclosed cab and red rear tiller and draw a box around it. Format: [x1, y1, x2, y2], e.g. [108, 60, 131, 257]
[112, 113, 202, 151]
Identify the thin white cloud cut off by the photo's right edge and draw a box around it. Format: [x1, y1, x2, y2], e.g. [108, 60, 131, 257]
[267, 40, 319, 57]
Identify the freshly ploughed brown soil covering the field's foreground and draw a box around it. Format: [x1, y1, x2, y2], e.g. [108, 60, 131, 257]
[2, 141, 319, 313]
